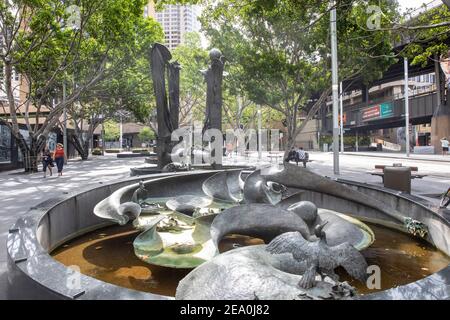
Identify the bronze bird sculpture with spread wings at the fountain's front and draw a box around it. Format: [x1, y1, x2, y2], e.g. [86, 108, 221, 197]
[266, 222, 367, 289]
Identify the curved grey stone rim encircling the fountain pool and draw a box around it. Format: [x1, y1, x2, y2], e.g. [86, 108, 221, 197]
[7, 171, 450, 300]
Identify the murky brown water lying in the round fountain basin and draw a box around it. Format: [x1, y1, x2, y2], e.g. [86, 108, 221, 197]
[52, 224, 450, 296]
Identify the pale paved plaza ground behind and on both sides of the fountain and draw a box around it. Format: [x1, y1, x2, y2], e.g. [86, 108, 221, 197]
[0, 152, 450, 299]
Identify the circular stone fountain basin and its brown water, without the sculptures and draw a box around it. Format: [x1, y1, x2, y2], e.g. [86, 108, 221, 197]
[7, 171, 450, 299]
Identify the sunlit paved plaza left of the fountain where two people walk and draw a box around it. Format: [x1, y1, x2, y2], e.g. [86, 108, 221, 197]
[0, 155, 143, 299]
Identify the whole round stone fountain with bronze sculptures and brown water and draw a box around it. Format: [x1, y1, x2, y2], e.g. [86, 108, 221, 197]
[7, 165, 450, 299]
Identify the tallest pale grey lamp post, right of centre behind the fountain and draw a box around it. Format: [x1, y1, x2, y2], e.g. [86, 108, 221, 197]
[330, 1, 339, 175]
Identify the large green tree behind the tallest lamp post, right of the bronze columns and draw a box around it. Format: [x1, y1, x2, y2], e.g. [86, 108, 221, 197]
[201, 0, 396, 153]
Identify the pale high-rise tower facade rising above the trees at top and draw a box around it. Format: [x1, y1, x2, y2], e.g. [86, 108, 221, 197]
[144, 1, 200, 49]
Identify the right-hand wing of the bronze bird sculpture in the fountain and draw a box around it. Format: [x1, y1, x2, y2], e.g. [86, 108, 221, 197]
[330, 242, 367, 282]
